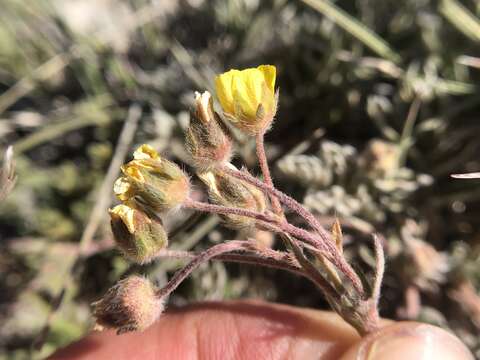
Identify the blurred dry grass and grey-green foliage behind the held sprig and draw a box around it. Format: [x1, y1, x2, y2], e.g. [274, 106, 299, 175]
[0, 0, 480, 359]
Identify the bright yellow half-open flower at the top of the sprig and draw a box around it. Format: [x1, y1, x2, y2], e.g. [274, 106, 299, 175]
[215, 65, 277, 135]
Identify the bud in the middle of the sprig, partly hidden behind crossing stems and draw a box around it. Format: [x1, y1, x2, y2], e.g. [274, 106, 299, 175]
[198, 171, 266, 229]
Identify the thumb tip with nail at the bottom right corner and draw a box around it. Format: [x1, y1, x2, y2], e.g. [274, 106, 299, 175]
[341, 322, 473, 360]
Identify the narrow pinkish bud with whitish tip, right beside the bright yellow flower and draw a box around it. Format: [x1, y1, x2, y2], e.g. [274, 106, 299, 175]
[185, 91, 232, 171]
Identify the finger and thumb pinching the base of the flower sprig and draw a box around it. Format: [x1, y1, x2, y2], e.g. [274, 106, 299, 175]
[51, 301, 473, 360]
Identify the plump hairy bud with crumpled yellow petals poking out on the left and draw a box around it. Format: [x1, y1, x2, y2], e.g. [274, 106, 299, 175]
[113, 145, 189, 211]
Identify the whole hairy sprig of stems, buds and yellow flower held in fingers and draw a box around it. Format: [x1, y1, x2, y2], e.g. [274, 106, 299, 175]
[94, 65, 384, 334]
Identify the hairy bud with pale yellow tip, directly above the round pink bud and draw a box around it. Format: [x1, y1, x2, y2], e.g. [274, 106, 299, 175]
[109, 203, 168, 264]
